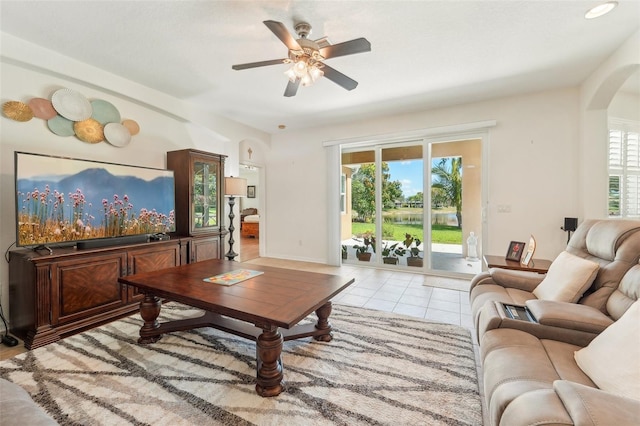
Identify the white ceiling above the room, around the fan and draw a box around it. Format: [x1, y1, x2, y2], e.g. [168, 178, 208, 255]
[0, 0, 640, 133]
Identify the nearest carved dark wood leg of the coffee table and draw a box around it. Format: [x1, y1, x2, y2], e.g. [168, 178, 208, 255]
[256, 325, 284, 397]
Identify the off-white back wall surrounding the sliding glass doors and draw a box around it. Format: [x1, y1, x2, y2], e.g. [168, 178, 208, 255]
[267, 88, 579, 262]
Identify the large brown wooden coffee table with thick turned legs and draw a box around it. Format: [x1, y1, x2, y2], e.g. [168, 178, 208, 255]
[118, 260, 354, 397]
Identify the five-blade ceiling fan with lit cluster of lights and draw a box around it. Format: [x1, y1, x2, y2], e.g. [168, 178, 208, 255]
[231, 21, 371, 97]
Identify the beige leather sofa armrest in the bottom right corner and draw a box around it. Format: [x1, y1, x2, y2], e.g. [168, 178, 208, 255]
[553, 380, 640, 426]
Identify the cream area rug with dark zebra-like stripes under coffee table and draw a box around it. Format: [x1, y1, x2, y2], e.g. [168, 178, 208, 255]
[0, 303, 482, 426]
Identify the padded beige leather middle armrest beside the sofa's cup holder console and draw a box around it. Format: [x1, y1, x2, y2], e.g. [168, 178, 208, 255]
[525, 299, 613, 334]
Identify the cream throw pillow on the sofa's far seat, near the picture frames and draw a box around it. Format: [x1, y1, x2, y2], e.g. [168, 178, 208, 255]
[533, 251, 600, 303]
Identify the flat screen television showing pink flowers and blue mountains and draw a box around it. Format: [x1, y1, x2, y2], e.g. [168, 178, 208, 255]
[15, 152, 175, 248]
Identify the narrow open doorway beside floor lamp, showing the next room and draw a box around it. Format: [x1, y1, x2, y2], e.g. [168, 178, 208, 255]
[238, 164, 262, 262]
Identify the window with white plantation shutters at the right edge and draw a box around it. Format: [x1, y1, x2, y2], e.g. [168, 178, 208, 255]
[609, 119, 640, 218]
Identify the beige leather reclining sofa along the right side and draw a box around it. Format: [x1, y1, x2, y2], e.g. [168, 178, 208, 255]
[470, 220, 640, 426]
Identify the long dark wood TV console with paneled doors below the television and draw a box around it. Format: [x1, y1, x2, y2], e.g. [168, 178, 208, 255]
[9, 233, 224, 349]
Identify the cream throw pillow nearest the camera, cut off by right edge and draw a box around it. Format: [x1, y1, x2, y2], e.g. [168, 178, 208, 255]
[574, 301, 640, 400]
